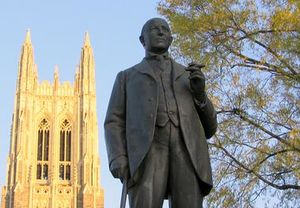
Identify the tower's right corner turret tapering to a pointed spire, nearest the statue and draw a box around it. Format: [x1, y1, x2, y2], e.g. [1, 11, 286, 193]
[79, 33, 99, 188]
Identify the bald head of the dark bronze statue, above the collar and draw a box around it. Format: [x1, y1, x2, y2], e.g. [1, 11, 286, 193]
[140, 18, 173, 53]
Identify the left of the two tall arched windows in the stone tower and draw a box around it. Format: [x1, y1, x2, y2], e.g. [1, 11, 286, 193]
[36, 119, 50, 180]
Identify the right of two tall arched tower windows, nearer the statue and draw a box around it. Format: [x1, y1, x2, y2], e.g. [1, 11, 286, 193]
[59, 119, 72, 180]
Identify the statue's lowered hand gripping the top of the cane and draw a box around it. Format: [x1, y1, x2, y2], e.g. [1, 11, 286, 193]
[110, 156, 129, 182]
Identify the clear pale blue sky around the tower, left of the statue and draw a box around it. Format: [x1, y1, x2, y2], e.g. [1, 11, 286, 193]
[0, 0, 171, 208]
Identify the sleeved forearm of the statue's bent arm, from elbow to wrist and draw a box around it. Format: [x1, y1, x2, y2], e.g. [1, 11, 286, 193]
[195, 95, 218, 139]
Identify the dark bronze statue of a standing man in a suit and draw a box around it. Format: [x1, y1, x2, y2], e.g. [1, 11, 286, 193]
[104, 18, 217, 208]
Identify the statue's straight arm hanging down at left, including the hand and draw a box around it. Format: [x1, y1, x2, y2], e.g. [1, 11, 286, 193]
[104, 71, 128, 174]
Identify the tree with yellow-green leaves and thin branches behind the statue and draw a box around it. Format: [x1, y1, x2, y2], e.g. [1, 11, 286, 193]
[158, 0, 300, 207]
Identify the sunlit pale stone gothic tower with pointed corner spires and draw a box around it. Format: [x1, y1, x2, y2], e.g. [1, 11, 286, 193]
[1, 31, 104, 208]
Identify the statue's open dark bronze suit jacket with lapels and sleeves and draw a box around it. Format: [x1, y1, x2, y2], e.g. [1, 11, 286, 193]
[104, 59, 217, 195]
